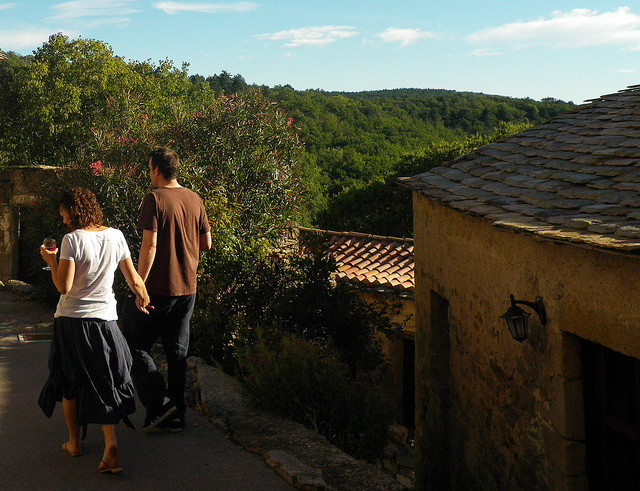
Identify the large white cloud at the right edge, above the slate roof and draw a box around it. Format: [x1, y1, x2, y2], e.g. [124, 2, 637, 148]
[467, 7, 640, 50]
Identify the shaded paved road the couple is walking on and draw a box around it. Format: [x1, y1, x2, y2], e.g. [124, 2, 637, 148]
[0, 291, 292, 491]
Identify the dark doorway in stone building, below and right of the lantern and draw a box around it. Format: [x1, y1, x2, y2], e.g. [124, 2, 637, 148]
[583, 341, 640, 491]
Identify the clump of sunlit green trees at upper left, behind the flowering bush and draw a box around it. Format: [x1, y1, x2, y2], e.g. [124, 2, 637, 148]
[0, 34, 214, 169]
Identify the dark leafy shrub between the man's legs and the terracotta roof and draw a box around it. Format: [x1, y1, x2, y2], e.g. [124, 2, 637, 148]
[192, 243, 402, 377]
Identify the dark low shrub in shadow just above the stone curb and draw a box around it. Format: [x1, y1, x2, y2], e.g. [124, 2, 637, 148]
[238, 335, 393, 461]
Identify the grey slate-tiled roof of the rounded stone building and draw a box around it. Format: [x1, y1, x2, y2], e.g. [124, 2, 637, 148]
[400, 86, 640, 254]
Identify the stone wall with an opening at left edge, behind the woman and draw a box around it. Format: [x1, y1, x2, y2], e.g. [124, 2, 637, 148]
[0, 166, 57, 281]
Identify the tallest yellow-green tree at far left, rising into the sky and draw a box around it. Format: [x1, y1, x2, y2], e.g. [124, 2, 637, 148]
[9, 34, 132, 165]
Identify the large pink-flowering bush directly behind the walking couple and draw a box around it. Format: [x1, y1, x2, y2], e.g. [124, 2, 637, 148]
[25, 92, 301, 310]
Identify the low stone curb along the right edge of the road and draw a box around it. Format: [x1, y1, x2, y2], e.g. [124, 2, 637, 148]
[190, 357, 411, 491]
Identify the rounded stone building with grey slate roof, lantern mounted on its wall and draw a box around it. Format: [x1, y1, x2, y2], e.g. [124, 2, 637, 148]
[402, 86, 640, 490]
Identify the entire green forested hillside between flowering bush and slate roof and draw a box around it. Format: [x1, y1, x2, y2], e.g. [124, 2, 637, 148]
[191, 72, 575, 235]
